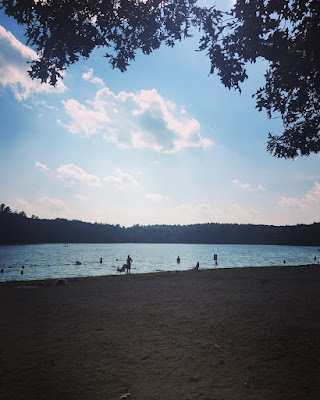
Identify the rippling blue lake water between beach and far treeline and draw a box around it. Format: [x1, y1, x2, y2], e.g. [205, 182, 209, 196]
[0, 243, 320, 281]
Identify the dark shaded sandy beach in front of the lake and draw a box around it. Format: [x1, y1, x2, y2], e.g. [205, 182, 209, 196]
[0, 266, 320, 400]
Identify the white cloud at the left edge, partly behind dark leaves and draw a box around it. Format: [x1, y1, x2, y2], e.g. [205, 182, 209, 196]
[0, 25, 66, 101]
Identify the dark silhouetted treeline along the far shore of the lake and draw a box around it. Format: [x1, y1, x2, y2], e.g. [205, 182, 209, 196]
[0, 204, 320, 246]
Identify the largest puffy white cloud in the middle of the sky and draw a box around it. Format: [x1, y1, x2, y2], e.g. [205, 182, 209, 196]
[58, 87, 213, 153]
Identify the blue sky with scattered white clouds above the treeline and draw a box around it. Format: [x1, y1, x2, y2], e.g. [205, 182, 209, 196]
[0, 0, 320, 226]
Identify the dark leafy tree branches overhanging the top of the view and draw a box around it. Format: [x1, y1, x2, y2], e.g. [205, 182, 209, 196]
[0, 0, 320, 158]
